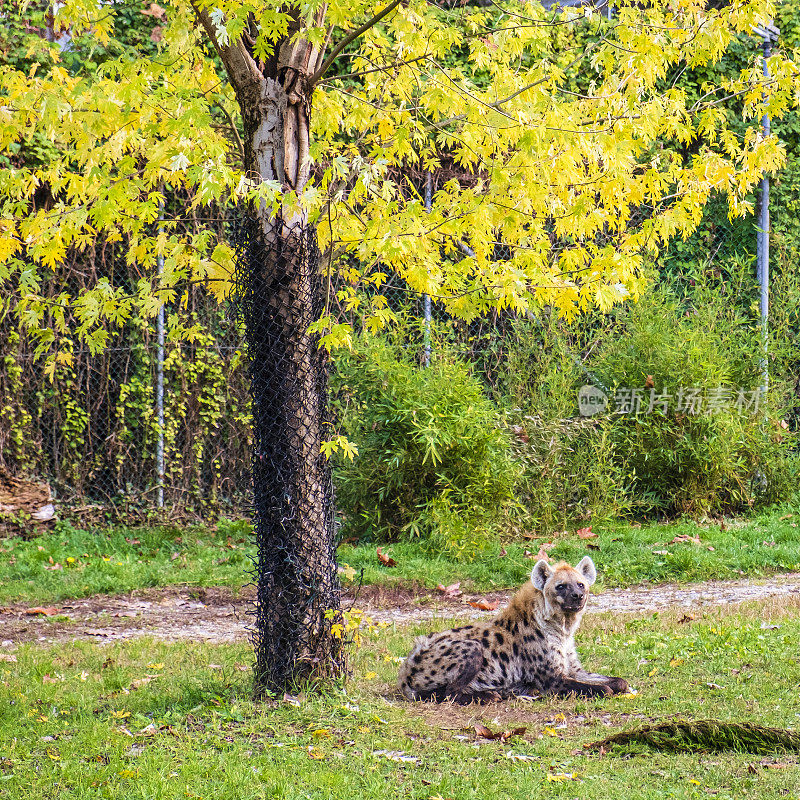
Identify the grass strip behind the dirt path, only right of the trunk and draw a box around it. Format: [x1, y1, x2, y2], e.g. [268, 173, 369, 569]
[339, 504, 800, 591]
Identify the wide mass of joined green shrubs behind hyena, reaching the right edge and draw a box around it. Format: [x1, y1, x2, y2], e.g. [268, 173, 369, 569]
[497, 280, 796, 532]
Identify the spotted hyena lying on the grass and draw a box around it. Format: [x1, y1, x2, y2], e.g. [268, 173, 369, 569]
[398, 556, 628, 703]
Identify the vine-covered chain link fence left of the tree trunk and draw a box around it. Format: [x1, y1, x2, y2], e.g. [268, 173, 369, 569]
[0, 206, 252, 524]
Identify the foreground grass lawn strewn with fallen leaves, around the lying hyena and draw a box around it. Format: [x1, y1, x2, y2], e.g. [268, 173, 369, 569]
[0, 601, 800, 800]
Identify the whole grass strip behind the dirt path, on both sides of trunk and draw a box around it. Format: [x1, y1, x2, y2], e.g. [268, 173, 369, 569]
[0, 504, 800, 604]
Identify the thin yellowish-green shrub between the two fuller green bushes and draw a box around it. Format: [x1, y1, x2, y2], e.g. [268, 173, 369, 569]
[496, 314, 630, 533]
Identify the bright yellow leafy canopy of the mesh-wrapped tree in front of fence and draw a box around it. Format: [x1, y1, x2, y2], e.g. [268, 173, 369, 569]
[0, 0, 800, 359]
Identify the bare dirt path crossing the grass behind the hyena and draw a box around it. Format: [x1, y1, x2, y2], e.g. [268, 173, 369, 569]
[0, 573, 800, 648]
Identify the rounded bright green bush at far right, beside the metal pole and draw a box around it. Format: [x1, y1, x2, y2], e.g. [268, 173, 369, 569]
[592, 287, 793, 515]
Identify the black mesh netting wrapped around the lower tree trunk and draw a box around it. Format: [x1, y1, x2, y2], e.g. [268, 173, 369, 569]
[235, 214, 343, 692]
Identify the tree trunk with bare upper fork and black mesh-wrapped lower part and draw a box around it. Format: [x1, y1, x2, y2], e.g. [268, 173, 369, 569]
[196, 8, 343, 695]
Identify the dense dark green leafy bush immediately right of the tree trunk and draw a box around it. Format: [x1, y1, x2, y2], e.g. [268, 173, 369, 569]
[332, 337, 519, 550]
